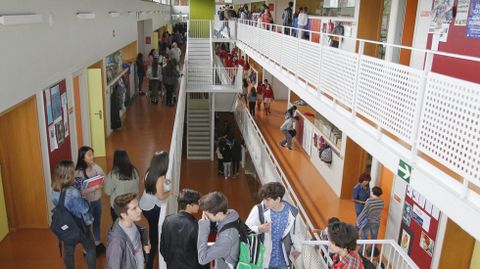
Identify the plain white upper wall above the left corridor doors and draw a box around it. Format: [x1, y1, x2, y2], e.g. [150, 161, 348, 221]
[0, 0, 170, 112]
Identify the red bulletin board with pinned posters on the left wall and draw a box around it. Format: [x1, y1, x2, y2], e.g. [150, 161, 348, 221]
[43, 80, 72, 174]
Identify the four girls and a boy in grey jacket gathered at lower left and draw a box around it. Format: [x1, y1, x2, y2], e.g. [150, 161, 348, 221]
[51, 146, 172, 269]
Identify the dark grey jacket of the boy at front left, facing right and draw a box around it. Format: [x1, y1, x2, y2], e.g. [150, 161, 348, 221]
[107, 219, 137, 269]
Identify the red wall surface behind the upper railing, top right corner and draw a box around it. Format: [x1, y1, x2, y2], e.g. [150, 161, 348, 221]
[427, 1, 480, 83]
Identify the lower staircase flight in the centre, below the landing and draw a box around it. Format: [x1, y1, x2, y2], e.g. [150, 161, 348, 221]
[187, 93, 212, 160]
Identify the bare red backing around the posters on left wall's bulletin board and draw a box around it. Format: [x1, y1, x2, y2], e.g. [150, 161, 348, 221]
[43, 80, 72, 175]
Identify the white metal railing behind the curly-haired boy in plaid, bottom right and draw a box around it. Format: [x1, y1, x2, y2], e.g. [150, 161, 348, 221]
[302, 240, 419, 269]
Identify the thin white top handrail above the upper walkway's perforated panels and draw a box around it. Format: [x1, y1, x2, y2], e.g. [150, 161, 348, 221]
[237, 20, 480, 62]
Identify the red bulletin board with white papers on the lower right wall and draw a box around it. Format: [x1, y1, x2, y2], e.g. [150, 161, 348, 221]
[398, 185, 440, 269]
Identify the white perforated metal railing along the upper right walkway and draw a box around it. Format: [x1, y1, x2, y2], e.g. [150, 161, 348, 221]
[237, 18, 480, 213]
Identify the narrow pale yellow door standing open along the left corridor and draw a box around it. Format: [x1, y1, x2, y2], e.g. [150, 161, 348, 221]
[88, 68, 106, 157]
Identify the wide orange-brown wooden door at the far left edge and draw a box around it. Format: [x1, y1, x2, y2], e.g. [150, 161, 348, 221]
[0, 97, 48, 228]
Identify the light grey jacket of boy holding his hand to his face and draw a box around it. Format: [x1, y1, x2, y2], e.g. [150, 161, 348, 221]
[197, 209, 240, 269]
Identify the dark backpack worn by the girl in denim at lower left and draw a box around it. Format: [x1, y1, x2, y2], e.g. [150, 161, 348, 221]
[50, 191, 86, 256]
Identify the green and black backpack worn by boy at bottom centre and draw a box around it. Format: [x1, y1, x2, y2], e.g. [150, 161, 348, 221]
[217, 218, 265, 269]
